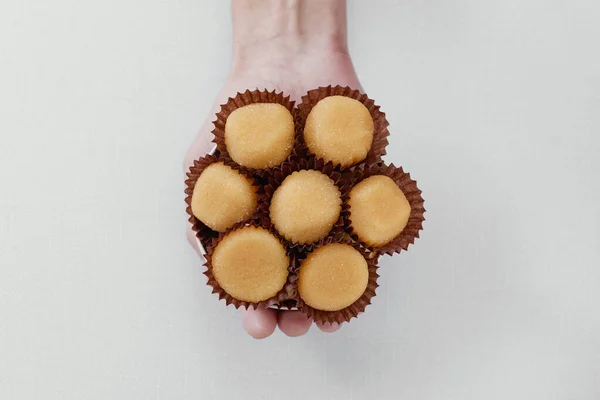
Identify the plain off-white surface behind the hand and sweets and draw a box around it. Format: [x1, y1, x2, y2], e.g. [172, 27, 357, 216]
[0, 0, 600, 400]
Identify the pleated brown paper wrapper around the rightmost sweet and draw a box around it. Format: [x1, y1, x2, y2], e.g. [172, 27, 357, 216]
[348, 163, 425, 255]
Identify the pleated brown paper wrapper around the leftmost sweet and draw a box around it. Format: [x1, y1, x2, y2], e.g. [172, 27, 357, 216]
[185, 155, 264, 251]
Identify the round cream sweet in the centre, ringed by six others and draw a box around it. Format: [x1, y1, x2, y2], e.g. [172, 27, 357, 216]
[269, 170, 342, 244]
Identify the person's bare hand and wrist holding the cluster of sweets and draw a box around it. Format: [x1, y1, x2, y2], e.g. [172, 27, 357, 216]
[184, 0, 361, 339]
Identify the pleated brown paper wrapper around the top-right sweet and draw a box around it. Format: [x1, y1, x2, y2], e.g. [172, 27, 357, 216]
[296, 86, 390, 169]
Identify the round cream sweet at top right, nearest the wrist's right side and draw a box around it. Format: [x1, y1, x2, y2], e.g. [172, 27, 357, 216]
[304, 96, 374, 167]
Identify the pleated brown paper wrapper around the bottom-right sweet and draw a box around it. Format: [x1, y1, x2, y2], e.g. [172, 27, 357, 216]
[292, 237, 379, 324]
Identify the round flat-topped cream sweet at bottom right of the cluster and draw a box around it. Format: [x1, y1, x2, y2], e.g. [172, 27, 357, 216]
[298, 243, 369, 311]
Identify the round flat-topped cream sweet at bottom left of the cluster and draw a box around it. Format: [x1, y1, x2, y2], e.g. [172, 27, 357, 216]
[212, 226, 290, 303]
